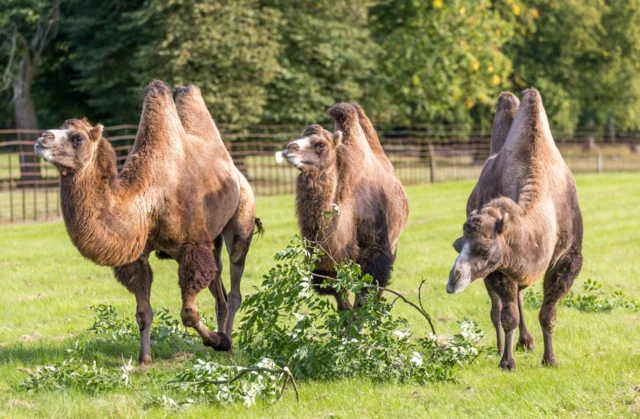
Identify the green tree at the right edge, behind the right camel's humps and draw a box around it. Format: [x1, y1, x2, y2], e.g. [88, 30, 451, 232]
[505, 0, 640, 133]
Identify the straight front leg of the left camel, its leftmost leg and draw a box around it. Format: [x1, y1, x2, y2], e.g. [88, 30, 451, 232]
[114, 250, 153, 364]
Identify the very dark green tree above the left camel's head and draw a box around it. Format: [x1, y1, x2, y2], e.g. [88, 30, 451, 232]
[61, 0, 146, 124]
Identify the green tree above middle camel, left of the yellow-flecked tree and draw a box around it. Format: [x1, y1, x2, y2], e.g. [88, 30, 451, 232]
[262, 0, 384, 124]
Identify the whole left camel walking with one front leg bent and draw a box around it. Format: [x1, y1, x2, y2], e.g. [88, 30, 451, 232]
[35, 80, 262, 364]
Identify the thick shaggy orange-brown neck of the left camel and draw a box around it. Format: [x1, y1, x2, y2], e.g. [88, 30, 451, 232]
[60, 139, 148, 267]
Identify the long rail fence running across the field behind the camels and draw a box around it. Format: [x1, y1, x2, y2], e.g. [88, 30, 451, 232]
[0, 125, 640, 224]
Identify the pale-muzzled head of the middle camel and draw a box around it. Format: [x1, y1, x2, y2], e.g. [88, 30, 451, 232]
[282, 125, 342, 172]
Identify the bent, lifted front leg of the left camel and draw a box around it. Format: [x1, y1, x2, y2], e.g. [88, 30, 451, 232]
[178, 245, 231, 351]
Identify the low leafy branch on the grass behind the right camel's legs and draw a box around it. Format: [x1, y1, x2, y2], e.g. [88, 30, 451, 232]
[524, 279, 640, 313]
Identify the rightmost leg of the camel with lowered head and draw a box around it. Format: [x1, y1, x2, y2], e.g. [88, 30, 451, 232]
[539, 253, 582, 366]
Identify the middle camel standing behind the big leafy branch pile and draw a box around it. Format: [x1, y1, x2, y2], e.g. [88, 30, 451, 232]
[282, 103, 409, 310]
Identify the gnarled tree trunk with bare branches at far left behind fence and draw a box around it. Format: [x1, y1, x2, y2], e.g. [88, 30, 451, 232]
[0, 0, 60, 181]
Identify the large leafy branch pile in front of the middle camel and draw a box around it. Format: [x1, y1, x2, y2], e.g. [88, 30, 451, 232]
[236, 237, 483, 384]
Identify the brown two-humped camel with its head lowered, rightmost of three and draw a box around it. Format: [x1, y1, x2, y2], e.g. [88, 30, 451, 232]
[447, 88, 582, 370]
